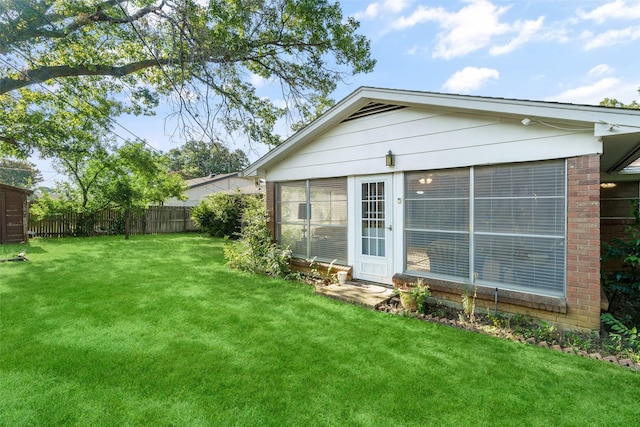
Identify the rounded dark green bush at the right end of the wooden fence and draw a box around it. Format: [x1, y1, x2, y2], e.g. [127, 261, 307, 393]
[191, 193, 249, 238]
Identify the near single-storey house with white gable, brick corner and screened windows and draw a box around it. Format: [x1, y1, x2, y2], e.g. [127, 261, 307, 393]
[243, 87, 640, 331]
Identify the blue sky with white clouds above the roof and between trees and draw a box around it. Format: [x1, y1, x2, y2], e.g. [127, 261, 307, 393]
[32, 0, 640, 185]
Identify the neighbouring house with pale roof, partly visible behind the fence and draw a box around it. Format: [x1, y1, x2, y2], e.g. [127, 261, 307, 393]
[164, 172, 264, 206]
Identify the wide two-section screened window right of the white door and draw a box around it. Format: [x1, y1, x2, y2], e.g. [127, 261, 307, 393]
[405, 161, 566, 296]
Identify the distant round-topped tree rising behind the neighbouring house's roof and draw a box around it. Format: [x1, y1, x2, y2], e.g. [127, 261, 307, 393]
[167, 141, 249, 179]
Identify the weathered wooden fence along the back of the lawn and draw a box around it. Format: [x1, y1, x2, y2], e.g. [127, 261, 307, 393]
[29, 206, 197, 237]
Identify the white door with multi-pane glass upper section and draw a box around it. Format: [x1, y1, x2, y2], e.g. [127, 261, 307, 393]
[353, 175, 393, 284]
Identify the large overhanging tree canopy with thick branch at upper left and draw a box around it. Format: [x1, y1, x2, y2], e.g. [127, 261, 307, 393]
[0, 0, 375, 156]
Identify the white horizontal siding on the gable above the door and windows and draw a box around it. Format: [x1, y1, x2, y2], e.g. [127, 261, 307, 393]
[267, 108, 602, 181]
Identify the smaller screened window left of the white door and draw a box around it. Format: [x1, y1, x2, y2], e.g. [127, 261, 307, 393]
[276, 178, 347, 264]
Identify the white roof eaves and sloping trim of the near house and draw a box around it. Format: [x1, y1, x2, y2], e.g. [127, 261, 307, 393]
[241, 87, 640, 180]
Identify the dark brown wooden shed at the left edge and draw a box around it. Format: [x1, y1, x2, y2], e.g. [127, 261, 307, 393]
[0, 184, 31, 244]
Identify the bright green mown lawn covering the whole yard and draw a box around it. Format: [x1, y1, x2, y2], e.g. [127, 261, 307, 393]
[0, 235, 640, 426]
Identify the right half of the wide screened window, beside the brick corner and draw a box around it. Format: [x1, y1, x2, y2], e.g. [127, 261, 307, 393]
[474, 161, 566, 296]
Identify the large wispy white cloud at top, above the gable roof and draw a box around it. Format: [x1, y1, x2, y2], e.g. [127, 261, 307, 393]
[391, 0, 544, 59]
